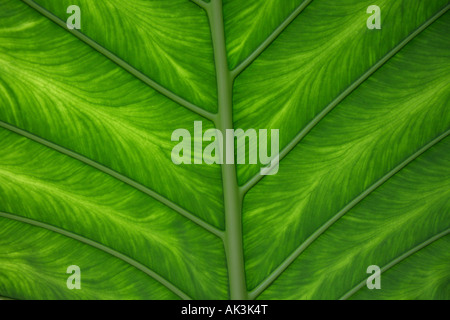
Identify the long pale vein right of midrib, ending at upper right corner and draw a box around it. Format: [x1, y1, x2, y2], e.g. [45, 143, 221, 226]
[240, 5, 450, 195]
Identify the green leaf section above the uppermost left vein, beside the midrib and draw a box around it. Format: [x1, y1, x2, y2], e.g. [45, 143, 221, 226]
[35, 0, 217, 111]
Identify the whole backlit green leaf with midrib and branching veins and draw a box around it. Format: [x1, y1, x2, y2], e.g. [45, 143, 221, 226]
[0, 0, 450, 299]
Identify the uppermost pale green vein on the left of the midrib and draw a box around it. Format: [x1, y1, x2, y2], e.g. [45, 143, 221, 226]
[22, 0, 216, 121]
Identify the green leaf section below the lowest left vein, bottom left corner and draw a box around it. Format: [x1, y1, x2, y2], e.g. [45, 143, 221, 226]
[0, 218, 179, 300]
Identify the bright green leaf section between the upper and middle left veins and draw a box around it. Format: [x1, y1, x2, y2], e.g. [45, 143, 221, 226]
[0, 1, 223, 227]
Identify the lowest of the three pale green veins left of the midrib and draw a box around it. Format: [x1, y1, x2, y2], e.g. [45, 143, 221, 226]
[0, 212, 191, 300]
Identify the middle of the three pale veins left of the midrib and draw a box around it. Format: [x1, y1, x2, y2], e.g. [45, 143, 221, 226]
[0, 121, 224, 239]
